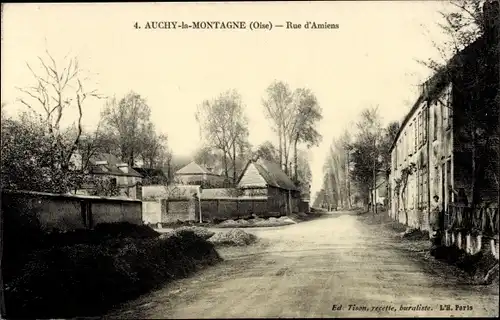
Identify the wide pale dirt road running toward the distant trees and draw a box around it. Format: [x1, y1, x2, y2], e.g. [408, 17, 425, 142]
[104, 212, 499, 318]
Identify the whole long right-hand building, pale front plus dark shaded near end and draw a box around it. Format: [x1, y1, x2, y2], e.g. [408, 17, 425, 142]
[389, 1, 500, 230]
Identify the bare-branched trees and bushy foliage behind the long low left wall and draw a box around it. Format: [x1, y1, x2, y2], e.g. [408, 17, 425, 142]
[1, 52, 170, 193]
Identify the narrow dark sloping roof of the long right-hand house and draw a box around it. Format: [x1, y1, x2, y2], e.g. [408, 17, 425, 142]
[390, 37, 485, 151]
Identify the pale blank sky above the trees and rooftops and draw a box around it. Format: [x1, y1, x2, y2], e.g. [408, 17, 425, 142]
[1, 1, 454, 202]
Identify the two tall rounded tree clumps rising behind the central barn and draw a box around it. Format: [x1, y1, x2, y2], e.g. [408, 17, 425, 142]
[195, 81, 322, 194]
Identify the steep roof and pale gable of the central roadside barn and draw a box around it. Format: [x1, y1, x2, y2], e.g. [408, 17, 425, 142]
[238, 158, 298, 191]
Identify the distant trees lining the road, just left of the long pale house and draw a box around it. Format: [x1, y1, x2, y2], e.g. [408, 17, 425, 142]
[315, 107, 399, 208]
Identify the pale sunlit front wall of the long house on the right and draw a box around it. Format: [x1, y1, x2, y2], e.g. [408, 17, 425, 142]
[389, 85, 453, 230]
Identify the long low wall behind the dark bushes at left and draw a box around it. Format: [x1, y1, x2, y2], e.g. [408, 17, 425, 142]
[2, 190, 142, 230]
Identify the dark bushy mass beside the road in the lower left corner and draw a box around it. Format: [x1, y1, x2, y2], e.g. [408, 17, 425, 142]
[4, 230, 221, 318]
